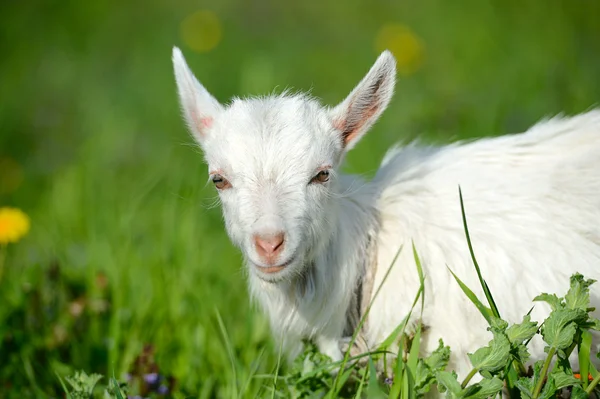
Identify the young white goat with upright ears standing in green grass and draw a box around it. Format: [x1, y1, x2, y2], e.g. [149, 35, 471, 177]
[173, 48, 600, 375]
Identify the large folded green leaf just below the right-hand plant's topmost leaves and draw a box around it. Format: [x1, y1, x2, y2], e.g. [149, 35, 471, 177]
[542, 309, 588, 350]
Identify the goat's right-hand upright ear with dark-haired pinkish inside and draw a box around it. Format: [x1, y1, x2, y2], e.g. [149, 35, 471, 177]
[330, 50, 396, 150]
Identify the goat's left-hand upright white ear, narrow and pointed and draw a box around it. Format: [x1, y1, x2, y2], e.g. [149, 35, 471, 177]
[173, 47, 223, 142]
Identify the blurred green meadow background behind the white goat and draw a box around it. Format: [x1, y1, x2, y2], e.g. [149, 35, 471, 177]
[0, 0, 600, 398]
